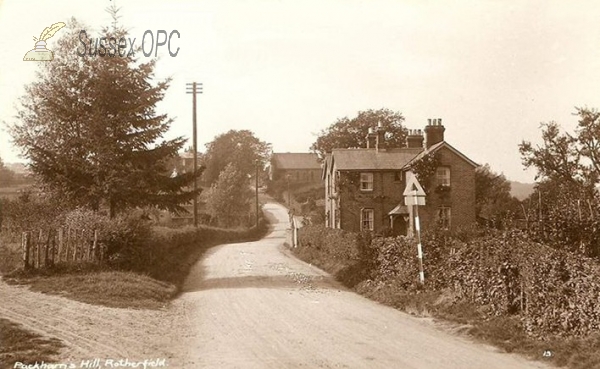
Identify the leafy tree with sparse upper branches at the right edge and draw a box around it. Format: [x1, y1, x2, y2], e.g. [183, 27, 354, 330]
[519, 108, 600, 257]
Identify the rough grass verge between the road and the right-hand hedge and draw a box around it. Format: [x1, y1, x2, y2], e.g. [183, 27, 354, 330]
[292, 247, 600, 369]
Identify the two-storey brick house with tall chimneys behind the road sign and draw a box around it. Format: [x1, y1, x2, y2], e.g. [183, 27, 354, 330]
[322, 119, 478, 235]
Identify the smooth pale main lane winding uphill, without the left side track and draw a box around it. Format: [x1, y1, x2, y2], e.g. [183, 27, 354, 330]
[180, 203, 545, 369]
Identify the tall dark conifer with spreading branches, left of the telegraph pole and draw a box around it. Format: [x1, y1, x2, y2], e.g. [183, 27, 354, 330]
[10, 13, 200, 216]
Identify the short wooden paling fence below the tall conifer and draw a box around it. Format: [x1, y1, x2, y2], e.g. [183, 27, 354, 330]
[21, 228, 106, 269]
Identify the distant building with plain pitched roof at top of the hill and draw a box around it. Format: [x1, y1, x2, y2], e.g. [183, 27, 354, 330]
[269, 153, 322, 184]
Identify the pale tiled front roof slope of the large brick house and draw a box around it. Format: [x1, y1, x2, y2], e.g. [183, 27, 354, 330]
[332, 148, 423, 170]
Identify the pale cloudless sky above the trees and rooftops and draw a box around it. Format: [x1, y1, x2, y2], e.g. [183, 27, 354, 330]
[0, 0, 600, 182]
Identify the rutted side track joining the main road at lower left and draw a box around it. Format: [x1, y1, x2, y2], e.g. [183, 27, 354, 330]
[0, 281, 190, 368]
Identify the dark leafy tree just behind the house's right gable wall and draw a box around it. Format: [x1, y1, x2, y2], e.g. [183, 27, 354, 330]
[475, 164, 521, 226]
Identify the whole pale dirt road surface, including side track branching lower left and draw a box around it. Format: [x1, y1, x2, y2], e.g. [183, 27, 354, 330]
[0, 203, 543, 369]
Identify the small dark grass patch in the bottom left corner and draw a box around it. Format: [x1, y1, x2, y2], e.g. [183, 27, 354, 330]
[0, 318, 63, 369]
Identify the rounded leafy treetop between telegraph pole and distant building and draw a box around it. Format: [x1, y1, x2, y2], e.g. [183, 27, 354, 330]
[203, 129, 271, 184]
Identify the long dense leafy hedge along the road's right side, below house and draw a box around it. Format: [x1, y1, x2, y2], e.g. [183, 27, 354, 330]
[299, 226, 600, 338]
